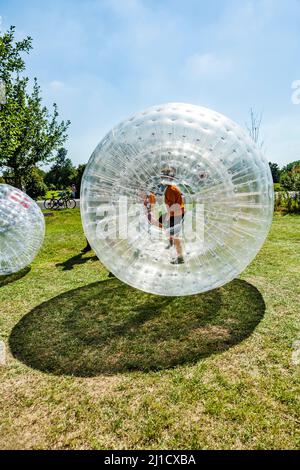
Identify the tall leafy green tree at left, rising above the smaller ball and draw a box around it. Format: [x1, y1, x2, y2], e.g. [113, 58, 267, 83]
[0, 26, 70, 189]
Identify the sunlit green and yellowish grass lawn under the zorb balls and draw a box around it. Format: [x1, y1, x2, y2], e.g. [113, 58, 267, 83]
[0, 209, 300, 449]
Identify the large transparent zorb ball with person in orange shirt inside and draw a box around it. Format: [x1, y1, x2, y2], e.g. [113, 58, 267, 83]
[81, 103, 274, 296]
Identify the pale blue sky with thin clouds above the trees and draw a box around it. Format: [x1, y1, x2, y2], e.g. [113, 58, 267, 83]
[0, 0, 300, 165]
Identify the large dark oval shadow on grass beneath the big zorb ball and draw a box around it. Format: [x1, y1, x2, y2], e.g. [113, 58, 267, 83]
[9, 279, 265, 377]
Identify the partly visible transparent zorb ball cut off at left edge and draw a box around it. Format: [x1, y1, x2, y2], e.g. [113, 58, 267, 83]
[0, 184, 45, 275]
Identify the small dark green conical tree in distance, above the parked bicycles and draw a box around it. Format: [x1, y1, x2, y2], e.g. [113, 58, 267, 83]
[45, 147, 77, 189]
